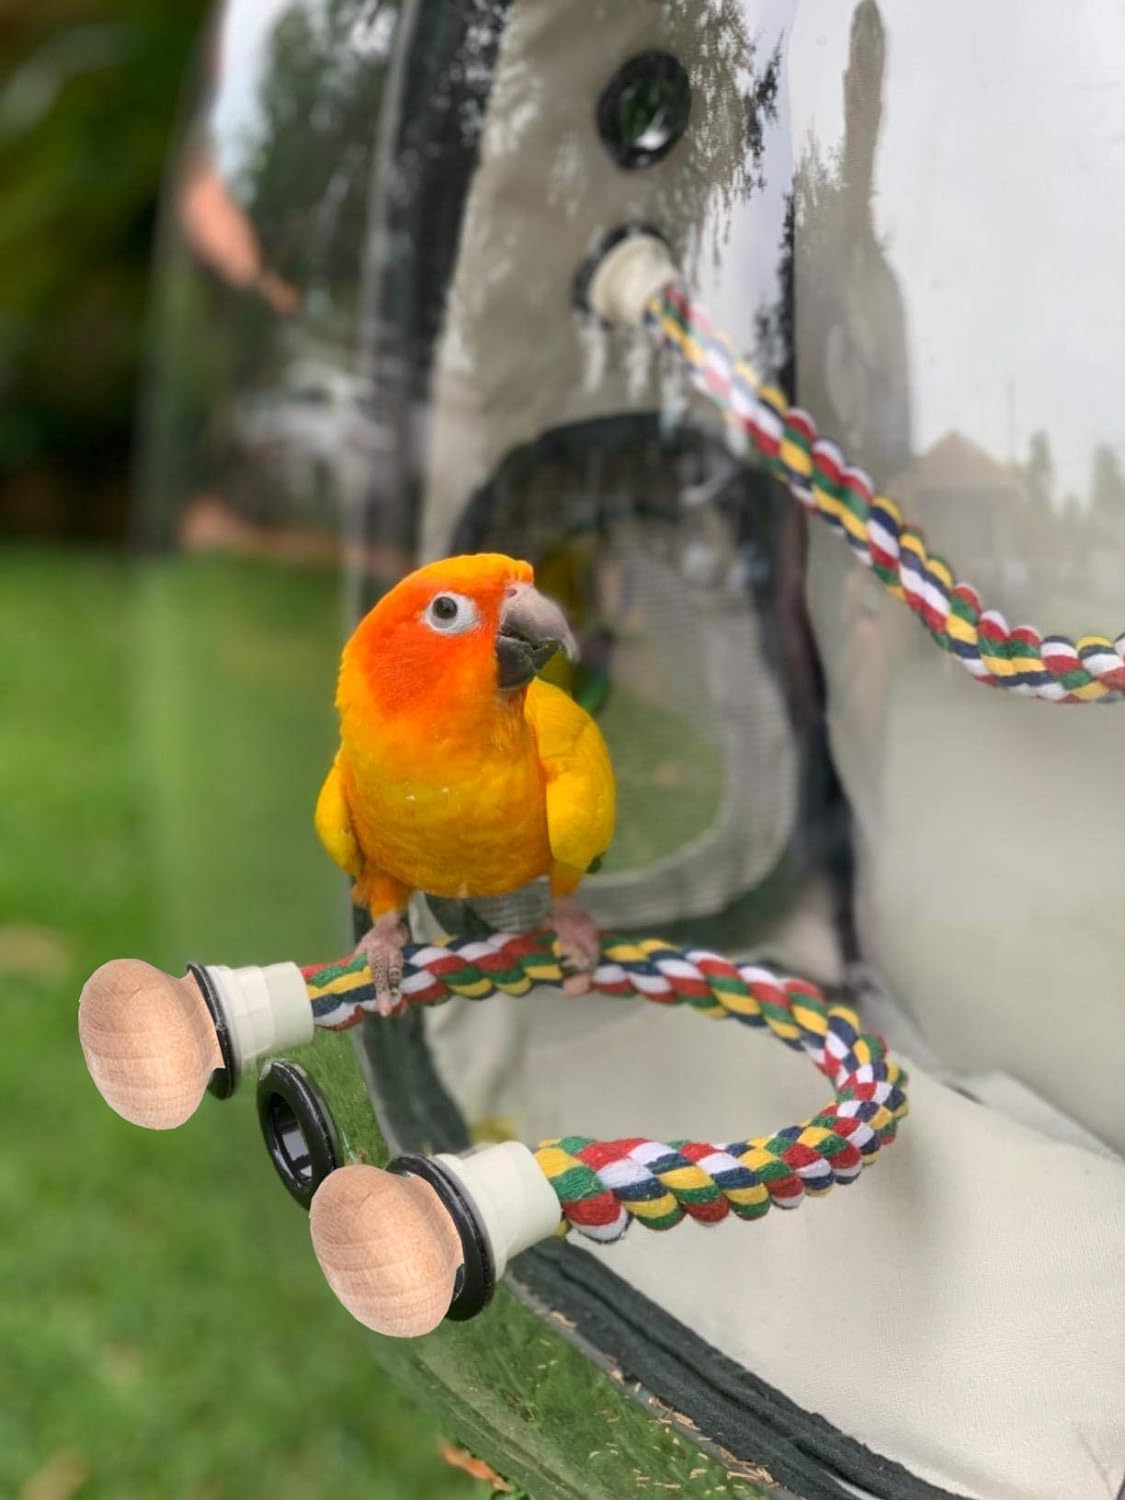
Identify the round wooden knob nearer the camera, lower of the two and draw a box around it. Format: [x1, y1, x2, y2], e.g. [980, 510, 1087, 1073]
[309, 1166, 464, 1338]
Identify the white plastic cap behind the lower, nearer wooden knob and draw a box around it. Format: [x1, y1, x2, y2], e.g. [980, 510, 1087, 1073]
[435, 1140, 563, 1281]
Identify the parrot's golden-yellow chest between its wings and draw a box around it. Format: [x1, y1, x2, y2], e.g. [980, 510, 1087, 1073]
[344, 705, 551, 897]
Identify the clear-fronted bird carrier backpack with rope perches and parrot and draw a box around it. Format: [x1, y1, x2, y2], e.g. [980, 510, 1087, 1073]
[78, 0, 1125, 1500]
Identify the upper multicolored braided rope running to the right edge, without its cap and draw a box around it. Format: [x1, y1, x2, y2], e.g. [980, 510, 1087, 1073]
[645, 282, 1125, 704]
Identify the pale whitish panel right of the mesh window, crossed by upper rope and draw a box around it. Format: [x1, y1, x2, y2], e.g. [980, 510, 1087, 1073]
[791, 5, 1125, 1151]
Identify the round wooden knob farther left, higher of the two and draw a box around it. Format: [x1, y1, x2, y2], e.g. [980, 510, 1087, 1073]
[78, 959, 222, 1130]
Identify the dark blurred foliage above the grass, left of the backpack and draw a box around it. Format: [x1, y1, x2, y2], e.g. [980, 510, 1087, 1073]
[0, 0, 209, 540]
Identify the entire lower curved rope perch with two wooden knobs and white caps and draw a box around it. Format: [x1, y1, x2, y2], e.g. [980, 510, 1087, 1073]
[78, 933, 906, 1337]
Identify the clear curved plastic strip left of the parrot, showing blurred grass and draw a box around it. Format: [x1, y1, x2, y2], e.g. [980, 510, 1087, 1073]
[137, 0, 404, 962]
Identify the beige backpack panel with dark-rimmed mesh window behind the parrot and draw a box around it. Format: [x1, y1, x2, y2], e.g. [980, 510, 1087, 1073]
[348, 6, 839, 944]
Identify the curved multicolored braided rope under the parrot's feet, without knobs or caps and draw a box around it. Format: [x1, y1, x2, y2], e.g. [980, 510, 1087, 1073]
[302, 933, 906, 1242]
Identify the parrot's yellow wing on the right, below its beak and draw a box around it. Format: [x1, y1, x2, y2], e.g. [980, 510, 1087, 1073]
[525, 678, 617, 888]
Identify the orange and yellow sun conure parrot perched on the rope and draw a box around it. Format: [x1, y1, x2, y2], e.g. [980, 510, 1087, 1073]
[317, 554, 615, 1011]
